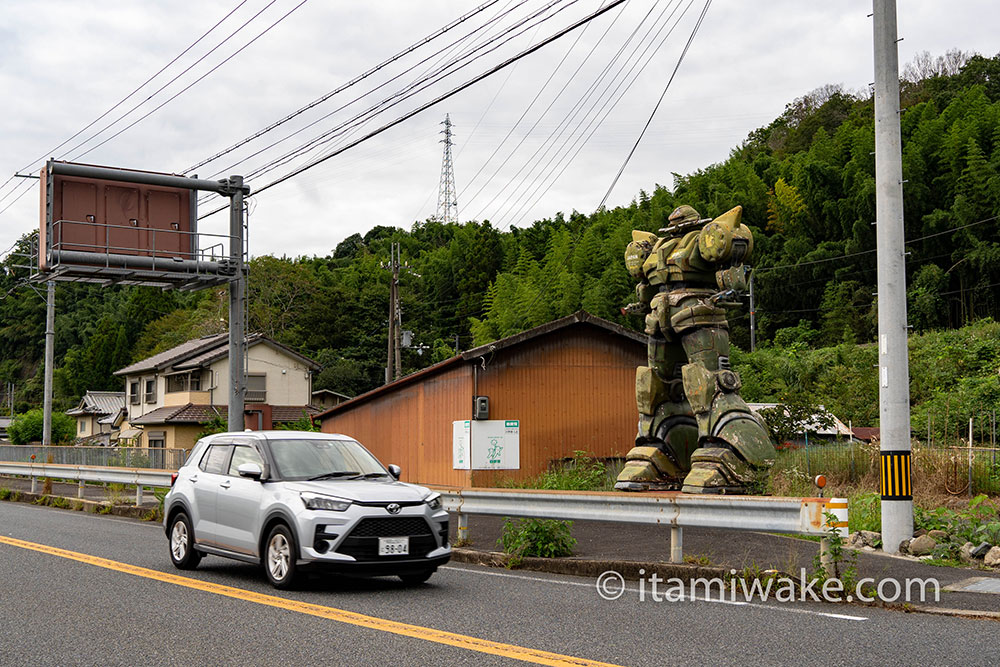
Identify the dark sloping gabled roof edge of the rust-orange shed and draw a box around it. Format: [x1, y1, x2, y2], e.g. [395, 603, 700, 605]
[316, 310, 646, 419]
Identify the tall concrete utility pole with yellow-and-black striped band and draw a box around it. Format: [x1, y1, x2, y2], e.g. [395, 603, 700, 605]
[873, 0, 913, 553]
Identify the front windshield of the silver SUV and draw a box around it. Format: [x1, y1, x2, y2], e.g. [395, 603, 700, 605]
[269, 438, 388, 480]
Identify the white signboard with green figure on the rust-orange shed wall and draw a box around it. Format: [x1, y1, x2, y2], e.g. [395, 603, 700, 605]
[452, 419, 521, 470]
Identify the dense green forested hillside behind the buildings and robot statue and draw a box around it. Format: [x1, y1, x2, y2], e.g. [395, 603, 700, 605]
[0, 52, 1000, 423]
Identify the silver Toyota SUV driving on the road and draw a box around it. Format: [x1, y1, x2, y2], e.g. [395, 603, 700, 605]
[163, 431, 451, 588]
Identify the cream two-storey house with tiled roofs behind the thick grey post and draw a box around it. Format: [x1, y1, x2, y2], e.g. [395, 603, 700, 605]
[115, 333, 319, 449]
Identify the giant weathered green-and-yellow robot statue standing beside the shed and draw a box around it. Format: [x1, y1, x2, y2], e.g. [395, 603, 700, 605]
[615, 206, 775, 493]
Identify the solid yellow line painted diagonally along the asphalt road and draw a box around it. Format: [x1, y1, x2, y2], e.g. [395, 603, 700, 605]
[0, 535, 615, 667]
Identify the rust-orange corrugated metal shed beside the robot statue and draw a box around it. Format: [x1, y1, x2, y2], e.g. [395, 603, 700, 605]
[317, 311, 646, 486]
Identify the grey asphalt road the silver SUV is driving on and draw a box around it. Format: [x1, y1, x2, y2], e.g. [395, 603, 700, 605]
[0, 502, 1000, 666]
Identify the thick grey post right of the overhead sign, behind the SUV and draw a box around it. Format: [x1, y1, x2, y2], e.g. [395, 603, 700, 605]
[227, 176, 246, 431]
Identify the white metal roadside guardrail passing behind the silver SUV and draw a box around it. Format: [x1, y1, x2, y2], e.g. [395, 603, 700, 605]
[0, 462, 847, 563]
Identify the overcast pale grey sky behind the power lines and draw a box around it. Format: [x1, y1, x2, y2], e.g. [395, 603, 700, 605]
[0, 0, 1000, 256]
